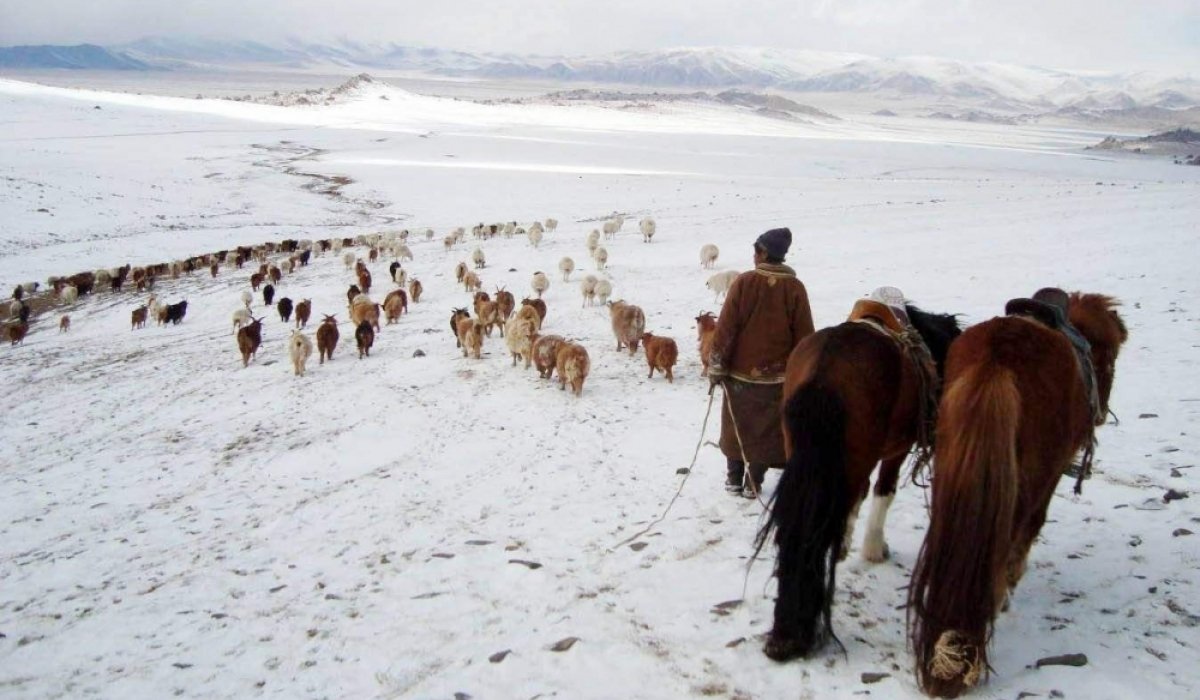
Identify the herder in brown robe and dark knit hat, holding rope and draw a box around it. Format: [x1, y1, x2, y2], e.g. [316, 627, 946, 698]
[708, 228, 812, 498]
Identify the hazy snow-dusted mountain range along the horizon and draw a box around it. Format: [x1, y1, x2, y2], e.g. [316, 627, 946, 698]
[0, 37, 1200, 112]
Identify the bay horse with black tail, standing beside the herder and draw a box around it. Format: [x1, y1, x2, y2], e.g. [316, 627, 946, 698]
[756, 300, 961, 662]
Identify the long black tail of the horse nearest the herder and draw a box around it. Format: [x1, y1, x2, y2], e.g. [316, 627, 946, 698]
[756, 383, 852, 662]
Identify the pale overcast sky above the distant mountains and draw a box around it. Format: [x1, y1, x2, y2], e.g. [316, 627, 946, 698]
[0, 0, 1200, 76]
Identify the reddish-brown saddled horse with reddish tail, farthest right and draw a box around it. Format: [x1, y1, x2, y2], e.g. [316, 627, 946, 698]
[908, 292, 1128, 698]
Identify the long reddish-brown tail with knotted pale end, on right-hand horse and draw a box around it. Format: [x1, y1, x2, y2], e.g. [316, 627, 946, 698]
[908, 364, 1020, 698]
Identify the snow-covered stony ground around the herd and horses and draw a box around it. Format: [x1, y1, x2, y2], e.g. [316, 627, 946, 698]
[0, 80, 1200, 698]
